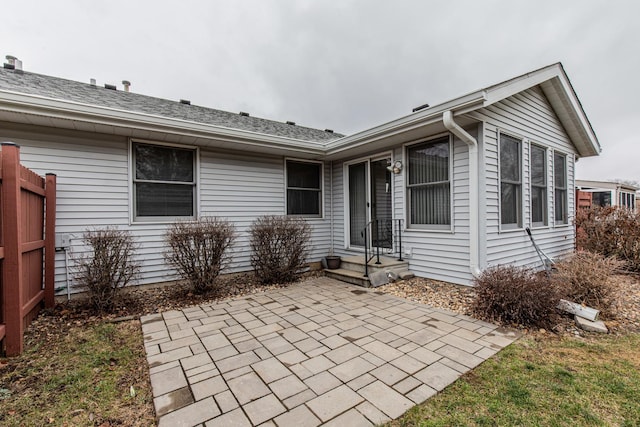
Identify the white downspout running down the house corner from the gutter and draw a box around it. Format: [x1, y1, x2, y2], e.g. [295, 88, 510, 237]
[442, 110, 481, 277]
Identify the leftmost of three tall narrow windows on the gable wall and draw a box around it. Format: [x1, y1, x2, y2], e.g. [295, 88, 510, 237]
[500, 134, 522, 229]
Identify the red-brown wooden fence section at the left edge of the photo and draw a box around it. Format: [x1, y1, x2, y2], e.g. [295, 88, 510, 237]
[0, 143, 56, 356]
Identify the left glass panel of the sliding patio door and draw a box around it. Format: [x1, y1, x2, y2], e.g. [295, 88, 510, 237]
[349, 162, 367, 246]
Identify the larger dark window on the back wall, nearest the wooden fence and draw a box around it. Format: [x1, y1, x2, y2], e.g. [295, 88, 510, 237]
[132, 142, 196, 218]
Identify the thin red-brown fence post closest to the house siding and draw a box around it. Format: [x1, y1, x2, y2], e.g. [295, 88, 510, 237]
[44, 173, 57, 308]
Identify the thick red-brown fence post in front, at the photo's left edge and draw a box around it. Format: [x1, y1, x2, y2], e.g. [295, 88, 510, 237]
[2, 142, 24, 356]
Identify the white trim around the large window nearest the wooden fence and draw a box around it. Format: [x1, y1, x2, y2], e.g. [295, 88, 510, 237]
[127, 138, 200, 225]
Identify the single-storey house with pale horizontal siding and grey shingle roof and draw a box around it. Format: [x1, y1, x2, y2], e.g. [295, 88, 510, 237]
[0, 59, 600, 294]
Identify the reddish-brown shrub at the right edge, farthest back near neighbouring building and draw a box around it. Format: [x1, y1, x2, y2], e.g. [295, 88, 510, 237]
[575, 206, 640, 272]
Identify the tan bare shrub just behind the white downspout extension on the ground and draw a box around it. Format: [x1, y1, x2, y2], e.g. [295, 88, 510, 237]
[551, 251, 624, 316]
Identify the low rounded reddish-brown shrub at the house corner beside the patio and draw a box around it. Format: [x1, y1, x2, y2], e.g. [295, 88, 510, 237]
[471, 266, 562, 327]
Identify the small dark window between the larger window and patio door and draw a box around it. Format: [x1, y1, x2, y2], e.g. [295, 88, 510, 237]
[286, 160, 322, 217]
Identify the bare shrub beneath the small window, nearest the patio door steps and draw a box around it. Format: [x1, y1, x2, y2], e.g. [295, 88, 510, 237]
[250, 216, 311, 284]
